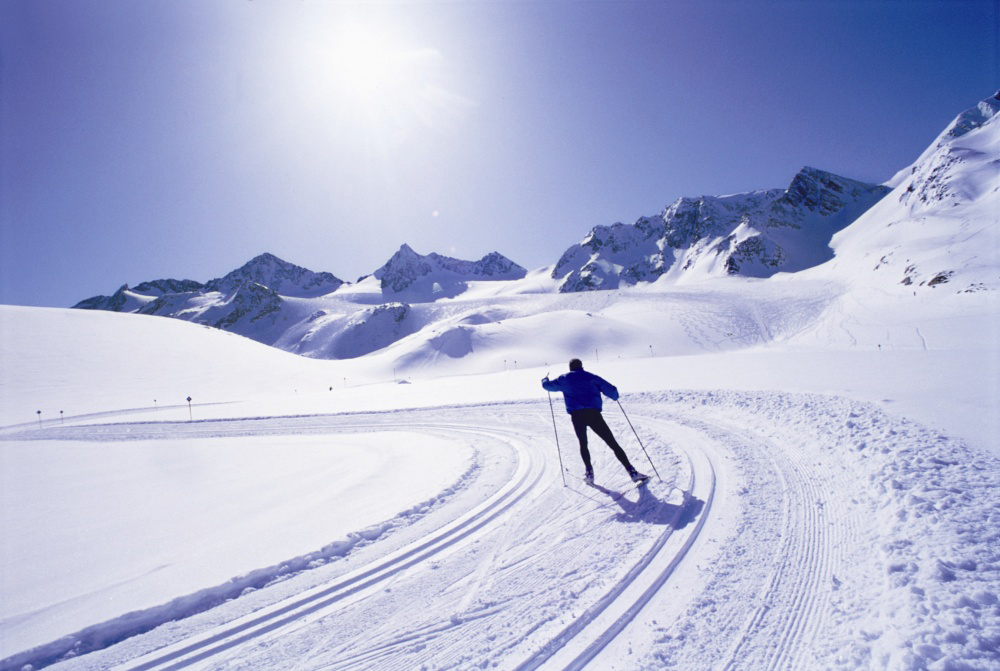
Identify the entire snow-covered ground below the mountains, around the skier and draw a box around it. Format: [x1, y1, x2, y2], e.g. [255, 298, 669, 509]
[0, 272, 1000, 669]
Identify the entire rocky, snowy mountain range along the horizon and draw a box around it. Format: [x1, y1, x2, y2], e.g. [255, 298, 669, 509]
[74, 92, 1000, 359]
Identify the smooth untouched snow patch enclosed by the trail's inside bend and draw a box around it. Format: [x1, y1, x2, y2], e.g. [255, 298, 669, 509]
[0, 431, 468, 648]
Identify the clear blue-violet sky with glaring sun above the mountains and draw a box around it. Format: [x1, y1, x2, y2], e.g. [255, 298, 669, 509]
[0, 0, 1000, 306]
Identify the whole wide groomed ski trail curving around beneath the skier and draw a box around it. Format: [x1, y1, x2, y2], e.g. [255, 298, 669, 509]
[15, 392, 992, 671]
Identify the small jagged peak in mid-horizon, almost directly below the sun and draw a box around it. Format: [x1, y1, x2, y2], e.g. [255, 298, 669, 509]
[373, 244, 528, 299]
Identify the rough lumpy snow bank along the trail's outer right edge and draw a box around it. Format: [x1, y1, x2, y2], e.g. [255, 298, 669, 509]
[644, 391, 1000, 671]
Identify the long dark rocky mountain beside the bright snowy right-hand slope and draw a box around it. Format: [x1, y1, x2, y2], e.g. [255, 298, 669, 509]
[552, 167, 889, 292]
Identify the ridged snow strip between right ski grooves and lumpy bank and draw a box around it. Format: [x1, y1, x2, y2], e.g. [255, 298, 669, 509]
[620, 394, 867, 671]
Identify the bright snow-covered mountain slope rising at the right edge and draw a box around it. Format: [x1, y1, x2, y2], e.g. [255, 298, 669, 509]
[810, 91, 1000, 293]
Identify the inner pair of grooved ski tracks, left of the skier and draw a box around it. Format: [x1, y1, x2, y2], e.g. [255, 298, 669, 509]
[107, 418, 546, 671]
